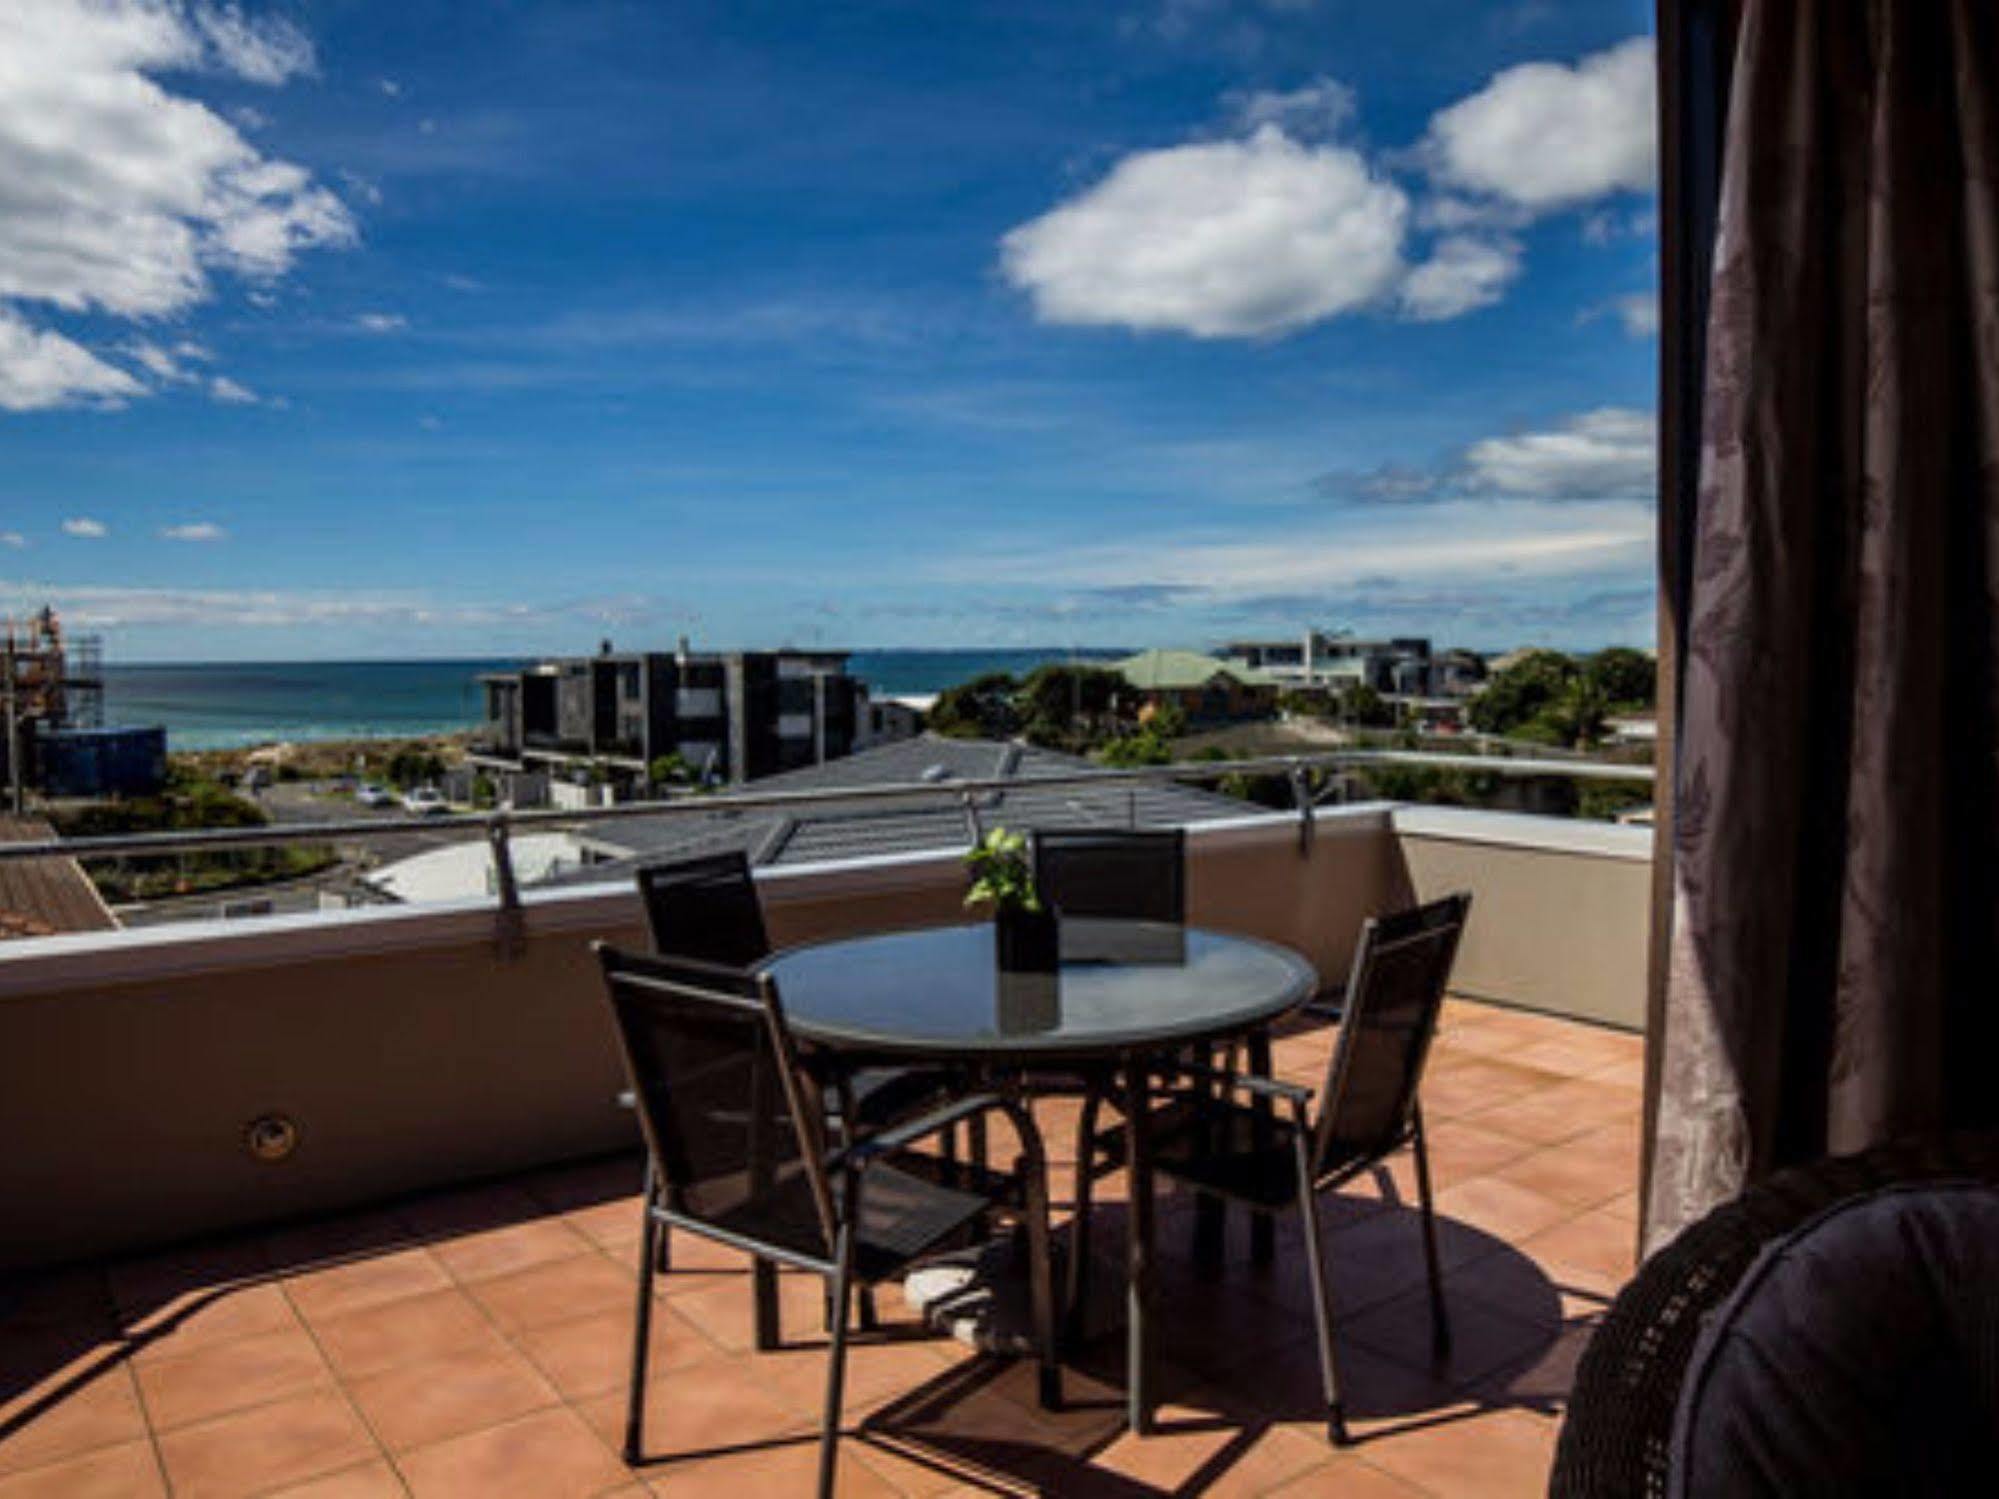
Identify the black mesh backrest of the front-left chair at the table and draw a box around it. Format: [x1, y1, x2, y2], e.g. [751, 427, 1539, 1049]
[596, 941, 836, 1257]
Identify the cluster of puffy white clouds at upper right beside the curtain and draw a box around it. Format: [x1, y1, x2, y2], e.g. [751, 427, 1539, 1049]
[1000, 36, 1657, 338]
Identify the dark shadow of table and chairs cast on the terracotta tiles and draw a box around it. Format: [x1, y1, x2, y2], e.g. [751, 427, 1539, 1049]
[854, 1203, 1607, 1499]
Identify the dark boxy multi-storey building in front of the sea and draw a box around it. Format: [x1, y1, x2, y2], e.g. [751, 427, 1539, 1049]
[472, 642, 868, 787]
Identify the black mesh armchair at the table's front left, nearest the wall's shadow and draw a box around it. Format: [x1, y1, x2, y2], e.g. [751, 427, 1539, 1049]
[596, 943, 1061, 1495]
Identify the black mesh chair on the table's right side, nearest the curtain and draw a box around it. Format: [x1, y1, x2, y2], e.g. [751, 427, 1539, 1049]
[1107, 895, 1471, 1445]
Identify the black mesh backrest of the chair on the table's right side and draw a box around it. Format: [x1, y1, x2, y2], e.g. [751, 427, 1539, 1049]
[1315, 895, 1471, 1167]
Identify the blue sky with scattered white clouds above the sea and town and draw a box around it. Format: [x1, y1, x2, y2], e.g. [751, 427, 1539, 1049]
[0, 0, 1655, 660]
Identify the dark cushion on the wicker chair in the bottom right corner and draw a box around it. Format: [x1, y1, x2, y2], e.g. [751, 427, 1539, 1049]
[1671, 1183, 1999, 1499]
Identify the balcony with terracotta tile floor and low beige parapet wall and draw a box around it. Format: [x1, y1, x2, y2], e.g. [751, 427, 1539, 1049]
[0, 803, 1651, 1497]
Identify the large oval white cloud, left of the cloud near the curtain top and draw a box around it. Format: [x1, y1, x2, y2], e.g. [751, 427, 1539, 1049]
[1001, 126, 1409, 338]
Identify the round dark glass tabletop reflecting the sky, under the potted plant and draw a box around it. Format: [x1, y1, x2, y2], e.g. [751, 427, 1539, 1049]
[770, 919, 1317, 1055]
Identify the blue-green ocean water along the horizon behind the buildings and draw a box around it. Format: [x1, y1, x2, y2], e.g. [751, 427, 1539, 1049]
[104, 650, 1119, 750]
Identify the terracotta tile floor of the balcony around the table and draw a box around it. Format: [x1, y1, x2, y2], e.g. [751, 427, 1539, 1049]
[0, 1001, 1641, 1499]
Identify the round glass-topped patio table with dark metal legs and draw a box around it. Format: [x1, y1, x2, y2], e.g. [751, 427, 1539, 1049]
[766, 919, 1319, 1433]
